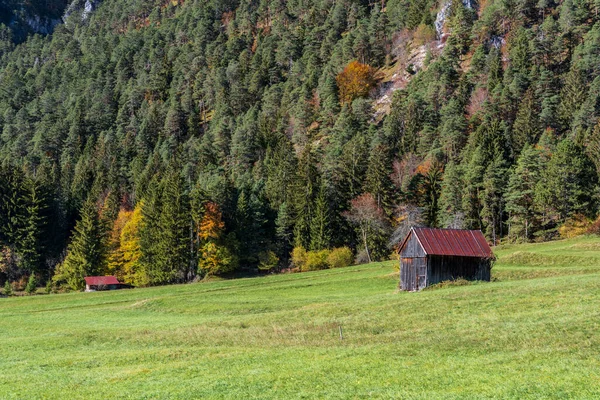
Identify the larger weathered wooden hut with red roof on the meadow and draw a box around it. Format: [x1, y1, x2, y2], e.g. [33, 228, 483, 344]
[399, 228, 494, 291]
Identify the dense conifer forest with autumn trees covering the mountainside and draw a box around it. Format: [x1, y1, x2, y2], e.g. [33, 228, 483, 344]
[0, 0, 600, 291]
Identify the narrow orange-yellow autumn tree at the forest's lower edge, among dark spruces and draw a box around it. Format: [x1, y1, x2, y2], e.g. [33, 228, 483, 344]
[198, 201, 237, 277]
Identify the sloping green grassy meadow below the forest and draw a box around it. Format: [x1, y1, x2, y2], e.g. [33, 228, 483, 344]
[0, 237, 600, 399]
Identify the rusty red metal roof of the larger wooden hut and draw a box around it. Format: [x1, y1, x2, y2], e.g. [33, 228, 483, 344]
[400, 228, 494, 258]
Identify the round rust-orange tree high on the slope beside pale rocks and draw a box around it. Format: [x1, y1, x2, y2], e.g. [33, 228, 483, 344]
[336, 61, 377, 104]
